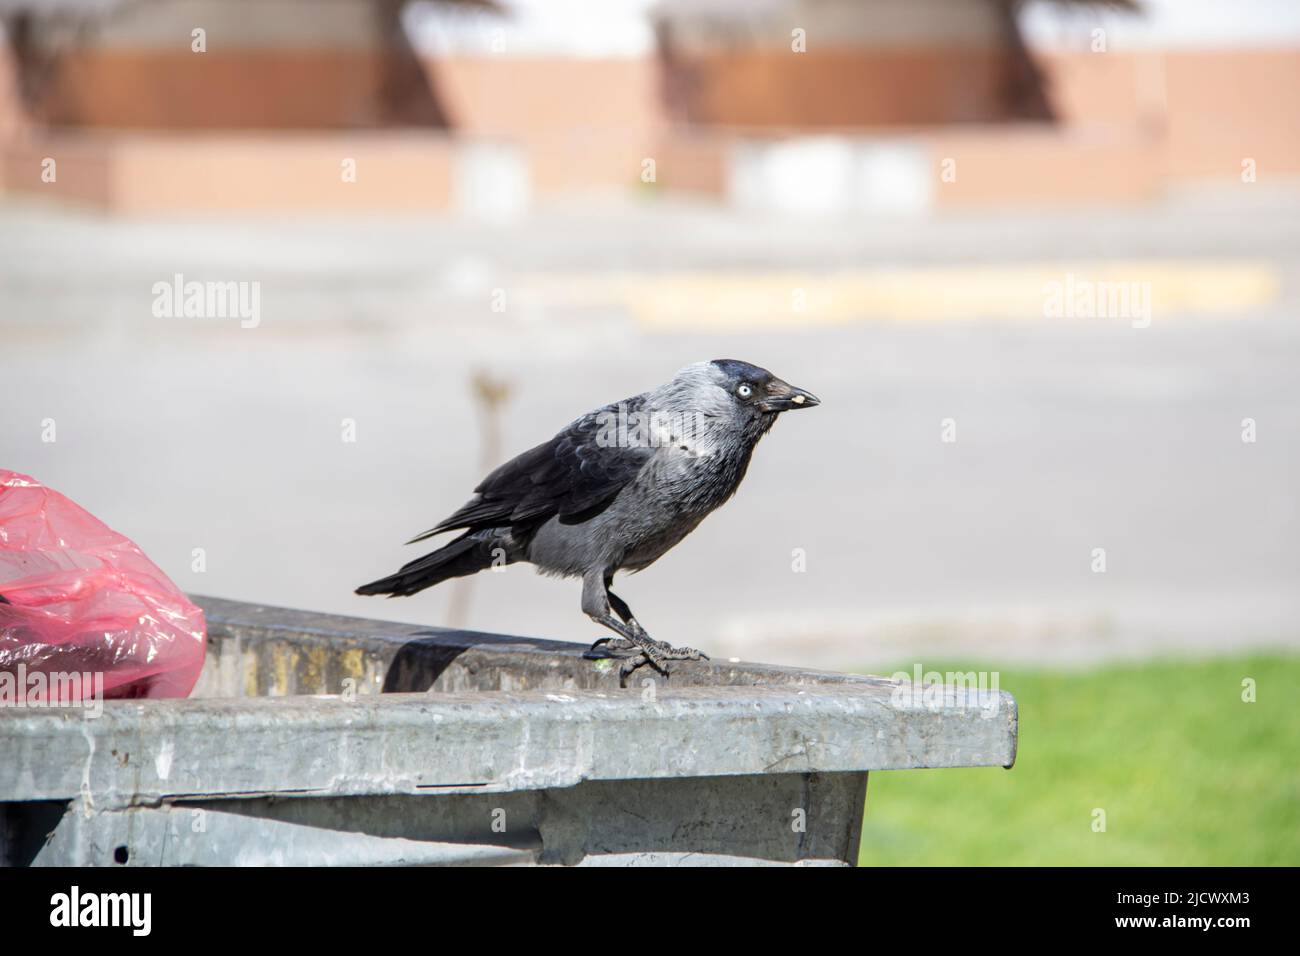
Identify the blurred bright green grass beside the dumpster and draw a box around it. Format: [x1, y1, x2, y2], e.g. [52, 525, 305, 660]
[861, 654, 1300, 866]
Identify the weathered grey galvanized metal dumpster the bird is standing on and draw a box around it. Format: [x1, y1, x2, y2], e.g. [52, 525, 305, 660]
[0, 598, 1017, 866]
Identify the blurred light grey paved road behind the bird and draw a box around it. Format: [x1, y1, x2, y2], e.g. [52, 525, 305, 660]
[0, 193, 1300, 669]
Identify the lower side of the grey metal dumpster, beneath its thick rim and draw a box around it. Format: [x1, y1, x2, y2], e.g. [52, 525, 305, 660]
[34, 774, 866, 866]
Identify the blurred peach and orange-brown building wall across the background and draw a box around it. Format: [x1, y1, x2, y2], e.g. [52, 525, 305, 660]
[0, 37, 1300, 211]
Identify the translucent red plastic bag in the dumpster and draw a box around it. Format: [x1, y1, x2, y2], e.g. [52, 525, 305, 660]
[0, 468, 207, 702]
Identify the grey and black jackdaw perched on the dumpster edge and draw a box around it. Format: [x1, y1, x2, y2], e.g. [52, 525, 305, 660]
[356, 359, 820, 687]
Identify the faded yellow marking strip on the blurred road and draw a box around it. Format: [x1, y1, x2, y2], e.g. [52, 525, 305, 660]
[512, 260, 1282, 330]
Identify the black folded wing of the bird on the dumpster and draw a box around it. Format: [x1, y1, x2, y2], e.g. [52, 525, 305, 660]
[408, 397, 654, 544]
